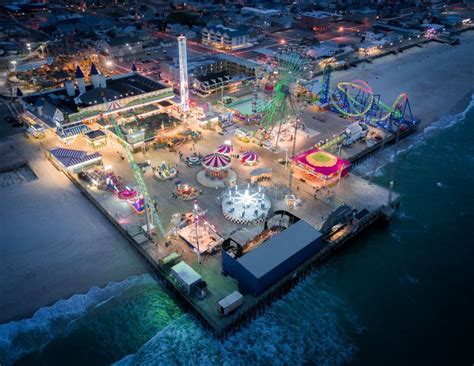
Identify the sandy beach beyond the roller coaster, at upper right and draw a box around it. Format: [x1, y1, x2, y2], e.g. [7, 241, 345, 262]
[333, 31, 474, 132]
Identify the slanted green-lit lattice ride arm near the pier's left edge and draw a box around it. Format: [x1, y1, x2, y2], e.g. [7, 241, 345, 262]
[109, 116, 166, 239]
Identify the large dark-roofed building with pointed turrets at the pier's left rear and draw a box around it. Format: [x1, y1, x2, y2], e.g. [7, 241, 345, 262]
[19, 64, 174, 142]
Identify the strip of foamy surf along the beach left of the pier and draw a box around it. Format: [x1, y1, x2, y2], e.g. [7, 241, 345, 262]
[0, 274, 156, 365]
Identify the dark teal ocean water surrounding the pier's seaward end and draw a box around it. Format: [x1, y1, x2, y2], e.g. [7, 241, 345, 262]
[0, 98, 474, 366]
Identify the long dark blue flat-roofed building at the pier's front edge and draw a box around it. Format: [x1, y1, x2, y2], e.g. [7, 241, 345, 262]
[222, 220, 323, 295]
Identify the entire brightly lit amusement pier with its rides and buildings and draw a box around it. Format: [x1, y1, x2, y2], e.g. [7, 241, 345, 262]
[10, 37, 419, 339]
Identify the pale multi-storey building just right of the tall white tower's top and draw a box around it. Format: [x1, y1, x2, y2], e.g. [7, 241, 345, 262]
[202, 24, 252, 51]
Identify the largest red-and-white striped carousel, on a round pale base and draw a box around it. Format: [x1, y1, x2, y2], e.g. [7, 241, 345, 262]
[197, 153, 237, 187]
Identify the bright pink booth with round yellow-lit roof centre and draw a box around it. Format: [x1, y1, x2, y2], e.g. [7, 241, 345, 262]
[292, 148, 351, 189]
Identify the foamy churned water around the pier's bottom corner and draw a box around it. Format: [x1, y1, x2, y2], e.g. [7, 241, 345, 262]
[115, 274, 364, 366]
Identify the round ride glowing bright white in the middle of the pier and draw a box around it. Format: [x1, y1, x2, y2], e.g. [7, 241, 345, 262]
[222, 186, 271, 225]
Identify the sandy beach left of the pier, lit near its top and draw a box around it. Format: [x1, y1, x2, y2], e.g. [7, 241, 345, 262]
[0, 140, 151, 323]
